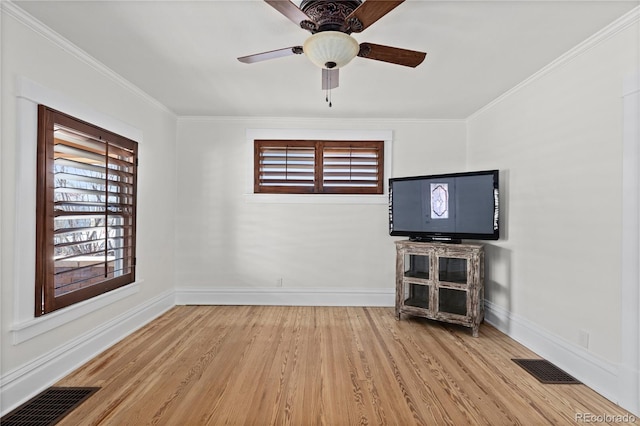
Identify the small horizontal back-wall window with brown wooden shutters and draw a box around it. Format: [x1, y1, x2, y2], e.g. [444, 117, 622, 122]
[253, 139, 384, 195]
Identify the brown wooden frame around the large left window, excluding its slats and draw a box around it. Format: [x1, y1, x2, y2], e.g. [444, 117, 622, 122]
[34, 104, 138, 317]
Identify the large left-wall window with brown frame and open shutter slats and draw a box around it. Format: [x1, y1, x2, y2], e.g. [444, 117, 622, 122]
[35, 105, 138, 316]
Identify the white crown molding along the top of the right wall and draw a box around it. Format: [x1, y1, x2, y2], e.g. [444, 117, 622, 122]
[465, 6, 640, 123]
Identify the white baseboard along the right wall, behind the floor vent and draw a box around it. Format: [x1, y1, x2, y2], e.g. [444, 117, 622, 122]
[485, 301, 637, 414]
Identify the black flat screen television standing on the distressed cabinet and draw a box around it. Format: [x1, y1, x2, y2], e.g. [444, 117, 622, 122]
[389, 170, 500, 242]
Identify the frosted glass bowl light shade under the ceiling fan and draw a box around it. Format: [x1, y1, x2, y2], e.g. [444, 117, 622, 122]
[302, 31, 360, 68]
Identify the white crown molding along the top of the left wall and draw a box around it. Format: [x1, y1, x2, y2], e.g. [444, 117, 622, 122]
[0, 0, 177, 117]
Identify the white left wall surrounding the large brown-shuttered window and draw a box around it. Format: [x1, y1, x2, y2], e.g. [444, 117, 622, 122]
[0, 2, 176, 412]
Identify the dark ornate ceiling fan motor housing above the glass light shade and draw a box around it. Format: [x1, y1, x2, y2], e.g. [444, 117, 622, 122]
[300, 0, 362, 34]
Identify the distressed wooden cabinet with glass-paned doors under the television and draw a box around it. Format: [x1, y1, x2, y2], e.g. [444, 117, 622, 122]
[396, 240, 484, 337]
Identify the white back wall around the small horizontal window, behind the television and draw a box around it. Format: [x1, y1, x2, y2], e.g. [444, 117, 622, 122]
[176, 118, 466, 305]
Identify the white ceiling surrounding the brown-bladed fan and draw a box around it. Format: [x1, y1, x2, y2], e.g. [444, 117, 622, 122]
[14, 0, 640, 119]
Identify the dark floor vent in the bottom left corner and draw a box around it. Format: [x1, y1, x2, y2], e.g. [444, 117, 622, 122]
[0, 387, 100, 426]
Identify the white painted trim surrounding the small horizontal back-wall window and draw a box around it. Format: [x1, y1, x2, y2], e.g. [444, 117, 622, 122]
[244, 128, 393, 205]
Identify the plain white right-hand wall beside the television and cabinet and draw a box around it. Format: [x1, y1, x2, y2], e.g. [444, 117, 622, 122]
[468, 11, 640, 406]
